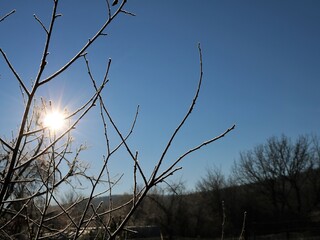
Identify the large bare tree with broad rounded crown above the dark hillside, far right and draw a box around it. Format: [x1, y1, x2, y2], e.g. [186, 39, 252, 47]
[235, 135, 314, 217]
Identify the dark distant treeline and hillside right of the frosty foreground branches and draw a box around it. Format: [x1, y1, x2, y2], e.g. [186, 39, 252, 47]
[107, 136, 320, 238]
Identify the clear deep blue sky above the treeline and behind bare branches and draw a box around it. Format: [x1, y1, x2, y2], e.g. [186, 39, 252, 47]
[0, 0, 320, 193]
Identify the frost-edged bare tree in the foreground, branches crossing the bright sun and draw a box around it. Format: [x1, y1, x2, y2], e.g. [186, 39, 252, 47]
[0, 0, 235, 239]
